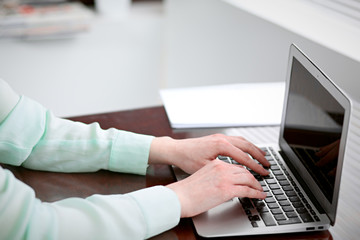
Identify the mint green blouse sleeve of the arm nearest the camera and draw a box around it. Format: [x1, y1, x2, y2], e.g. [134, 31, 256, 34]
[0, 167, 180, 240]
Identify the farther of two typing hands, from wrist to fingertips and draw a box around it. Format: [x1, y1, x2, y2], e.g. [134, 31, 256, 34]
[149, 134, 270, 175]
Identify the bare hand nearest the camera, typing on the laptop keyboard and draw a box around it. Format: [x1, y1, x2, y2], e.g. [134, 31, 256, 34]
[167, 160, 266, 217]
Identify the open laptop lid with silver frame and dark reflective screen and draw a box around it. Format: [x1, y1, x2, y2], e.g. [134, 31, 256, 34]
[279, 45, 351, 224]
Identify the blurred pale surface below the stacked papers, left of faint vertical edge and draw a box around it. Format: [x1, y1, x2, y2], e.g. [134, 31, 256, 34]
[0, 2, 163, 117]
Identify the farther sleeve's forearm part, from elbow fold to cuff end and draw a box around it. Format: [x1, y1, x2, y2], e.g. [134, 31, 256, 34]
[23, 109, 153, 174]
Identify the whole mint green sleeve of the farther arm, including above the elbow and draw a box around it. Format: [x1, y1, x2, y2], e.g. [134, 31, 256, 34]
[0, 94, 153, 174]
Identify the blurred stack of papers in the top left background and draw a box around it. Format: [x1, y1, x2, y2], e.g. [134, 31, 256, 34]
[0, 2, 94, 39]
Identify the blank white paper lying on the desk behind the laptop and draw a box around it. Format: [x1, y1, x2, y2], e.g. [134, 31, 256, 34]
[160, 82, 285, 128]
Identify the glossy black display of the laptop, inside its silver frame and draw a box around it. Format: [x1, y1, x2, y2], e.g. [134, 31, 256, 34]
[283, 58, 345, 203]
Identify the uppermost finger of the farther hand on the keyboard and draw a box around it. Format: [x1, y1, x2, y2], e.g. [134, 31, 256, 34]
[229, 137, 270, 167]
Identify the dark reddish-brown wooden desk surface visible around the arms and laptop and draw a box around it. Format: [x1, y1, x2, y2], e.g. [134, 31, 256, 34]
[4, 107, 332, 240]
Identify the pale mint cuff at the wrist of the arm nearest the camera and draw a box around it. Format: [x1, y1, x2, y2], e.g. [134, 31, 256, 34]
[127, 186, 181, 238]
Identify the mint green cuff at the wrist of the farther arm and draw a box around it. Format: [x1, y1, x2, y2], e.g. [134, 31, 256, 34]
[109, 131, 154, 175]
